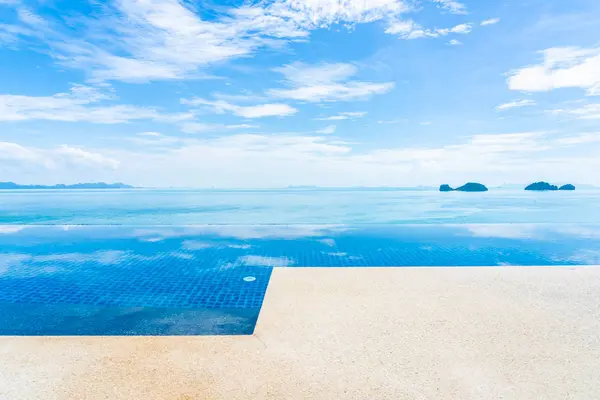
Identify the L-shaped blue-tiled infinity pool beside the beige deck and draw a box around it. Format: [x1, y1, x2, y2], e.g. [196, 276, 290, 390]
[0, 224, 600, 335]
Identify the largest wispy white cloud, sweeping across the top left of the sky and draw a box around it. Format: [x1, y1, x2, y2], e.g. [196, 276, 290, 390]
[0, 0, 410, 82]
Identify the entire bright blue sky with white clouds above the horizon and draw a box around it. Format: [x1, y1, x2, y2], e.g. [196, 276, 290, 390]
[0, 0, 600, 188]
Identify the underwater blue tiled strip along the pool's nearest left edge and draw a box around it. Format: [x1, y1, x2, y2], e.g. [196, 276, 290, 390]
[0, 303, 260, 336]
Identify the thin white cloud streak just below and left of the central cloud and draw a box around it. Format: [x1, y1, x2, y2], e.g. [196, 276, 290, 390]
[181, 97, 298, 118]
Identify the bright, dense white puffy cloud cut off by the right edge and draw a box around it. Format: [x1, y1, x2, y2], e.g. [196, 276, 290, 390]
[507, 47, 600, 96]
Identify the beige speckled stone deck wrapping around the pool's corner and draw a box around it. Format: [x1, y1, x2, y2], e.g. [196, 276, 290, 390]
[0, 267, 600, 400]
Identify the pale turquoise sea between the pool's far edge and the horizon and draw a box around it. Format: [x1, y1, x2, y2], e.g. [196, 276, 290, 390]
[0, 189, 600, 225]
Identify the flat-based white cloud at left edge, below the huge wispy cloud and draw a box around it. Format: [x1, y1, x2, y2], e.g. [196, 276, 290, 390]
[0, 85, 192, 124]
